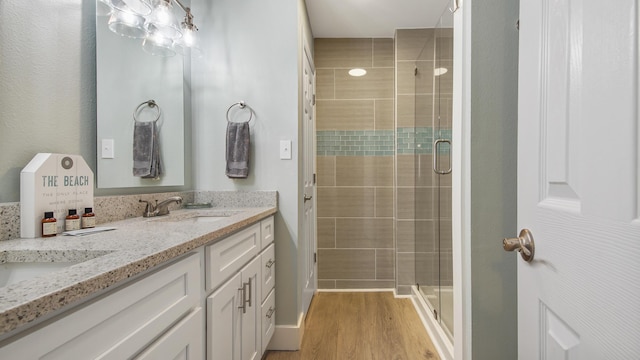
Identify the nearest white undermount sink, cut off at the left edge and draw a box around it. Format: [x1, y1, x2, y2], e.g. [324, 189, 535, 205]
[0, 250, 111, 288]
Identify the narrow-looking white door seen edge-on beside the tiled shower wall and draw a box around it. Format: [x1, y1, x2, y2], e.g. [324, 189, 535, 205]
[301, 46, 318, 314]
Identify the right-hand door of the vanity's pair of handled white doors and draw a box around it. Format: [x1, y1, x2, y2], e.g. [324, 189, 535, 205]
[242, 256, 262, 360]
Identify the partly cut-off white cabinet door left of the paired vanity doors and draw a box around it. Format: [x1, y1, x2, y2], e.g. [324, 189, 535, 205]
[135, 308, 203, 360]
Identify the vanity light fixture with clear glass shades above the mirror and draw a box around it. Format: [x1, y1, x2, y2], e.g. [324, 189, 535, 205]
[100, 0, 201, 56]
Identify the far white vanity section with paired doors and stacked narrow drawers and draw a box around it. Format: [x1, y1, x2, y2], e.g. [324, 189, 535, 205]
[205, 217, 275, 360]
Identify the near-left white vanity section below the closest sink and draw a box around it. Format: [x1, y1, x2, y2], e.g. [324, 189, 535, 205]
[0, 253, 203, 360]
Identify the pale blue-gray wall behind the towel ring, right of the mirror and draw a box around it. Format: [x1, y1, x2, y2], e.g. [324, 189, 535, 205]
[191, 0, 301, 324]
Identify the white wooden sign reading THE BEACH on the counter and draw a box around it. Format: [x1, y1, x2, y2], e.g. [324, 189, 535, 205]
[20, 153, 93, 238]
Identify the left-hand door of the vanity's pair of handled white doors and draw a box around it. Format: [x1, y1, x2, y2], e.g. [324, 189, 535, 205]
[207, 273, 243, 360]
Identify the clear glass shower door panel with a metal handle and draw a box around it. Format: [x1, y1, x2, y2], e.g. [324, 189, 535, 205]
[412, 2, 455, 356]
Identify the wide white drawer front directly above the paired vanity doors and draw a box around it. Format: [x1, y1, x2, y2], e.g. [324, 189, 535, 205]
[205, 224, 260, 291]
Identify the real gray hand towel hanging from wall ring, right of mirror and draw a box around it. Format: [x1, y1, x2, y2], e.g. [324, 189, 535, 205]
[226, 122, 251, 179]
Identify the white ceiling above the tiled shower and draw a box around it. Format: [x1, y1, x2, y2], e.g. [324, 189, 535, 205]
[305, 0, 449, 38]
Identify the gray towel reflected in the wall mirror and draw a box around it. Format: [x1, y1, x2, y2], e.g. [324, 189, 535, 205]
[133, 121, 162, 179]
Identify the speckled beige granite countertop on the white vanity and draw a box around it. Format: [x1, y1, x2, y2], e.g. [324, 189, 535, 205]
[0, 207, 277, 337]
